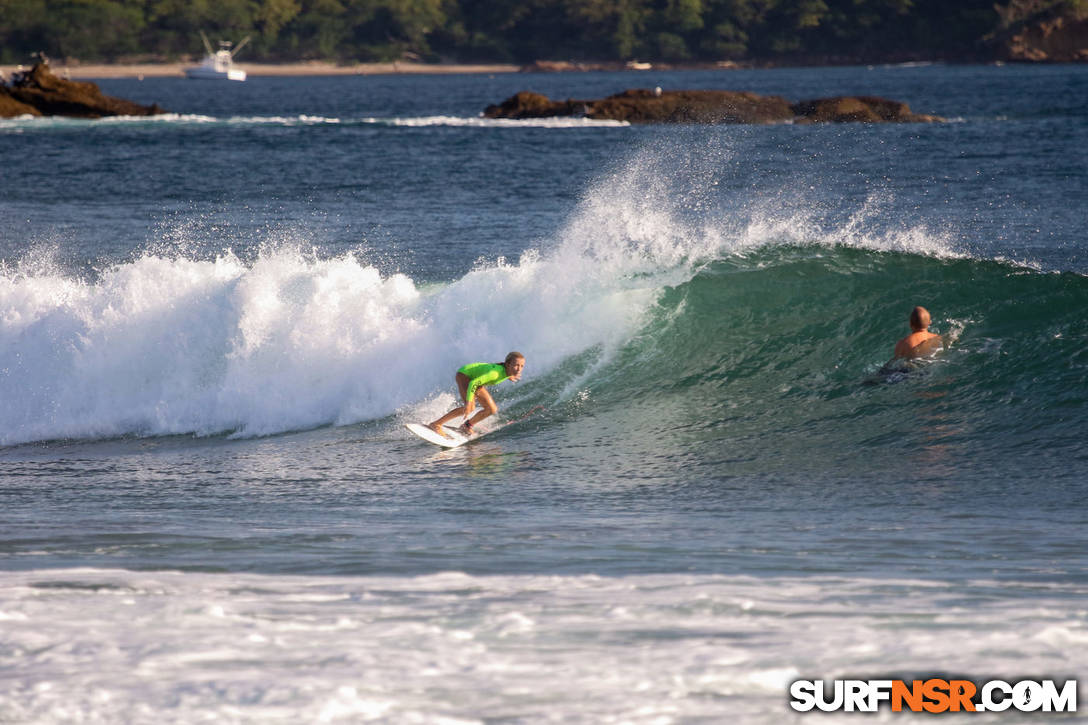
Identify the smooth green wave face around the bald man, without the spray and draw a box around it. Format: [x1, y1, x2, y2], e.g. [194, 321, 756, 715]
[598, 245, 1088, 470]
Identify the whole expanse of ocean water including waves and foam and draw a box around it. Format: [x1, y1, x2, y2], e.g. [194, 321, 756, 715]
[0, 65, 1088, 723]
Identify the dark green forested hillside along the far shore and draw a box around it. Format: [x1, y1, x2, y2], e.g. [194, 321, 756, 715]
[0, 0, 1088, 63]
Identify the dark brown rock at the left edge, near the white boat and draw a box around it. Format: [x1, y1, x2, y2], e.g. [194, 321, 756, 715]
[0, 63, 165, 119]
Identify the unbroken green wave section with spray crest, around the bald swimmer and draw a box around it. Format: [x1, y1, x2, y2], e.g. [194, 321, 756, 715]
[537, 144, 1088, 472]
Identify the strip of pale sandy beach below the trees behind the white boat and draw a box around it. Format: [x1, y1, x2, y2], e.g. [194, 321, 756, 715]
[0, 61, 521, 79]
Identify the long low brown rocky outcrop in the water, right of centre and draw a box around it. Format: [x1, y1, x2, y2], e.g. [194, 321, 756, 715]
[483, 88, 943, 123]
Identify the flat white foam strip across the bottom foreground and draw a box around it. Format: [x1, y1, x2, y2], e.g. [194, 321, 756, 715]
[0, 569, 1088, 724]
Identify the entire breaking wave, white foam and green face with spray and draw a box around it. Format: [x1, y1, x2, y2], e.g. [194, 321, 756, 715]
[0, 140, 1088, 455]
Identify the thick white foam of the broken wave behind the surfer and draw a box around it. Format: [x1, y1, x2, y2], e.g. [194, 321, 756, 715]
[0, 231, 655, 444]
